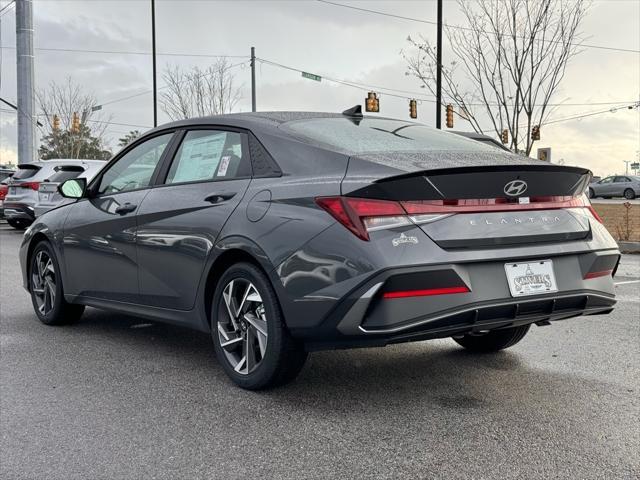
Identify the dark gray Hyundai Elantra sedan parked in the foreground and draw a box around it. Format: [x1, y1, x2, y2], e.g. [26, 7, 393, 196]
[20, 108, 620, 389]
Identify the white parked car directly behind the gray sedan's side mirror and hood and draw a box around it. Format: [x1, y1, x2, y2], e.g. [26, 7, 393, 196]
[34, 160, 107, 218]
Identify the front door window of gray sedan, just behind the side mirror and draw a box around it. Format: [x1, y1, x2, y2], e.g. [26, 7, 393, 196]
[98, 133, 173, 193]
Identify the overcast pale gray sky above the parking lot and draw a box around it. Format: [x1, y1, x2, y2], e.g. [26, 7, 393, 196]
[0, 0, 640, 176]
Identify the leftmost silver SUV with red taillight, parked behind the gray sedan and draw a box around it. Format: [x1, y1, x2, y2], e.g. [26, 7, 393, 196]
[4, 159, 101, 229]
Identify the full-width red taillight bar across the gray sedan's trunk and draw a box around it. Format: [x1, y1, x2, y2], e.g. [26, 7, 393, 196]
[316, 195, 602, 241]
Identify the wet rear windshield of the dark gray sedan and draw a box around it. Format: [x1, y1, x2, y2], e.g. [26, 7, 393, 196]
[281, 117, 495, 154]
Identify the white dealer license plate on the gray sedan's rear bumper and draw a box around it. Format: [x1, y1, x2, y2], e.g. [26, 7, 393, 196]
[504, 260, 558, 297]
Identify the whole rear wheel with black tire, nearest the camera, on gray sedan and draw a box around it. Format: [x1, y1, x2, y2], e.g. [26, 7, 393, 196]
[211, 263, 307, 390]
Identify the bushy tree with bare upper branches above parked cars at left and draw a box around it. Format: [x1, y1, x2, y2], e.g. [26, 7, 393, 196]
[36, 77, 109, 158]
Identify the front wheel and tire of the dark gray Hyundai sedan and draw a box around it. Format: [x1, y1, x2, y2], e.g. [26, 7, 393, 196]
[28, 241, 84, 325]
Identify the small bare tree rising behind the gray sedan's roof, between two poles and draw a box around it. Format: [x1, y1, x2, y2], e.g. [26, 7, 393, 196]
[160, 58, 242, 120]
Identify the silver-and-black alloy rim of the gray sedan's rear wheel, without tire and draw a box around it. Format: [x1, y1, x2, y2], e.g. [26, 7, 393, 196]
[217, 278, 267, 375]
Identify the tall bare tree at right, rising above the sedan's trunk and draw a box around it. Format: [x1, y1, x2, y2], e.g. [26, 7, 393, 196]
[403, 0, 589, 155]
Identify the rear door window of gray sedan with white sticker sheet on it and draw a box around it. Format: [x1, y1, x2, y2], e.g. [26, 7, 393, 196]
[165, 130, 251, 184]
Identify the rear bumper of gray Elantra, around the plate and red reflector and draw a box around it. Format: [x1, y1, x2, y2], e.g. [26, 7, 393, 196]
[292, 250, 619, 350]
